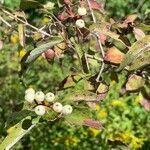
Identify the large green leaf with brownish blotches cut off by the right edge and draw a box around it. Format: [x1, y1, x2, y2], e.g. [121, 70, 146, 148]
[117, 35, 150, 71]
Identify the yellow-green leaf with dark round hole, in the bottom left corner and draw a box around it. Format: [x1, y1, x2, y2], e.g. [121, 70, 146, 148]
[0, 118, 39, 150]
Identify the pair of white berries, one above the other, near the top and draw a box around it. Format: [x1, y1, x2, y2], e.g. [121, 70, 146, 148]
[76, 7, 87, 28]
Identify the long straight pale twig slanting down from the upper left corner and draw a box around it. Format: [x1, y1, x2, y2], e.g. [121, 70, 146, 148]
[2, 9, 51, 37]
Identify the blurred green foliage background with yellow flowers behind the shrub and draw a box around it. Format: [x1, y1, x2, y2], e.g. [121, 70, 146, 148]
[0, 0, 150, 150]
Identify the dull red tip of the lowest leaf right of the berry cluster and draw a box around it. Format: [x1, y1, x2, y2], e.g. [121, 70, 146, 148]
[83, 119, 102, 130]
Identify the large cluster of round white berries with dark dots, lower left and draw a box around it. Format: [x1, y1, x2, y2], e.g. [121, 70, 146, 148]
[25, 88, 73, 116]
